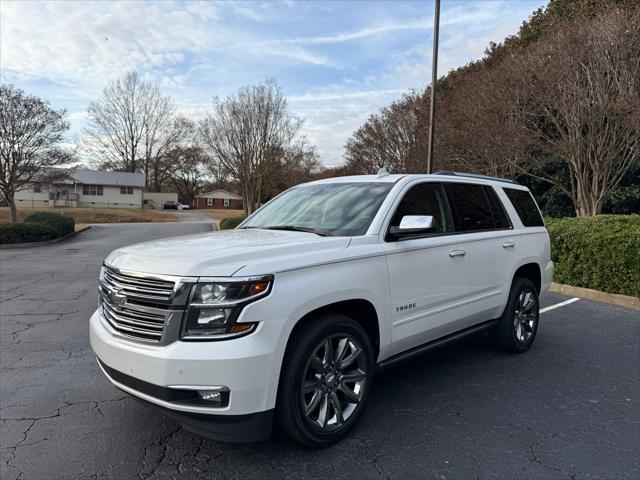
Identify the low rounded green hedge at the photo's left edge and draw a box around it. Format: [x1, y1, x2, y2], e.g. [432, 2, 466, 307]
[0, 212, 76, 244]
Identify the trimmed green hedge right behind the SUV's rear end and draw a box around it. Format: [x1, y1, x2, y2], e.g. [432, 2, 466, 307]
[547, 215, 640, 297]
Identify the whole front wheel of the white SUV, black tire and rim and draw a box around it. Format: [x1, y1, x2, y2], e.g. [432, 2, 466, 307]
[276, 314, 375, 447]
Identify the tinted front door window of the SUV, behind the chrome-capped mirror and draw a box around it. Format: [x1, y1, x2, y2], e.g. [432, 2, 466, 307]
[389, 183, 453, 234]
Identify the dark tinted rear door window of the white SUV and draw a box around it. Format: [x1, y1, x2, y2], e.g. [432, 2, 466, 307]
[447, 183, 496, 232]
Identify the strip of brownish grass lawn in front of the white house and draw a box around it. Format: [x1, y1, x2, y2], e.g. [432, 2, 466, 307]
[0, 207, 177, 223]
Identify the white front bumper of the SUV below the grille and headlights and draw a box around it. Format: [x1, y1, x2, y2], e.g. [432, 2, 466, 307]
[90, 311, 285, 441]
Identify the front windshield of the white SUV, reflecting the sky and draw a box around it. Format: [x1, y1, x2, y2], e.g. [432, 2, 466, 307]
[242, 183, 393, 236]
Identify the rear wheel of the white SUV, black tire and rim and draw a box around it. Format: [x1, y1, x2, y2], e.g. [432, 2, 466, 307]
[490, 277, 540, 353]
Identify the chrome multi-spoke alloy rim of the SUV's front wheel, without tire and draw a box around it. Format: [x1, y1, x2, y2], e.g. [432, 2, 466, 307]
[301, 334, 368, 432]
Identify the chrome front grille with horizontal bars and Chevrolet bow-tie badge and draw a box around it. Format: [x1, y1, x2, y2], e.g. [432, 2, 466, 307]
[100, 267, 191, 344]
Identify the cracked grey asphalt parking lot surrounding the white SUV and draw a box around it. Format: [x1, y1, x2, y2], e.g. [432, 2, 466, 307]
[0, 223, 640, 480]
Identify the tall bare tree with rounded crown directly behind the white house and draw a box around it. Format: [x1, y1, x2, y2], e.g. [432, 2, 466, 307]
[86, 72, 176, 183]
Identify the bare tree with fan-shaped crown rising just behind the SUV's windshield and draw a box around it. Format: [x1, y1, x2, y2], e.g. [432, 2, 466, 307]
[200, 80, 302, 214]
